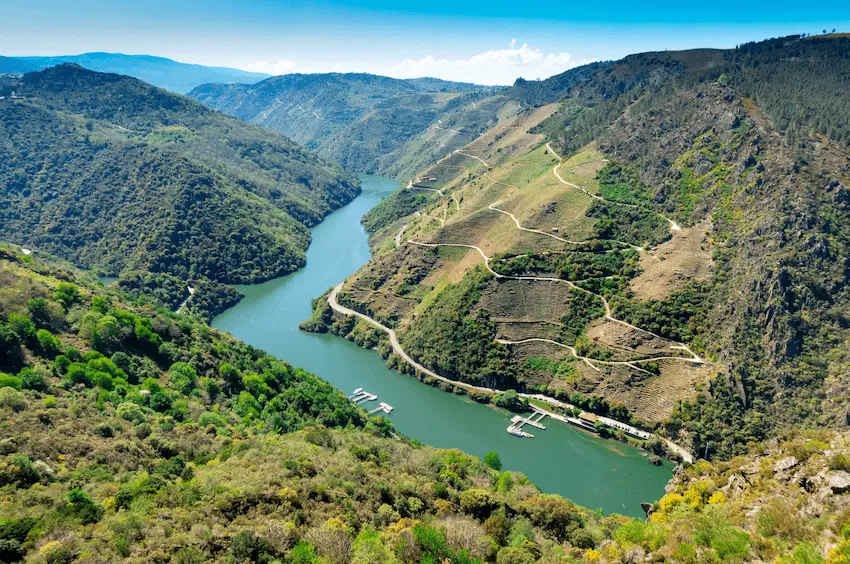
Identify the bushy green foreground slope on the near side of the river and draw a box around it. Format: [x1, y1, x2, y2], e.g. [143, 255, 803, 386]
[0, 245, 850, 564]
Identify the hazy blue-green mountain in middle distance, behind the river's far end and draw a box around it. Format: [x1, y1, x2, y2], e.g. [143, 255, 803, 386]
[189, 73, 501, 175]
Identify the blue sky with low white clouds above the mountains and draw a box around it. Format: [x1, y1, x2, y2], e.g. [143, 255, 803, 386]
[0, 0, 850, 84]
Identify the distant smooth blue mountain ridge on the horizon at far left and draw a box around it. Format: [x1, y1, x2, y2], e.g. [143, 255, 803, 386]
[0, 53, 269, 94]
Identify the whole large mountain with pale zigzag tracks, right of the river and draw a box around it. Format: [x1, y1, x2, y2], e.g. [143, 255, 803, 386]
[307, 35, 850, 459]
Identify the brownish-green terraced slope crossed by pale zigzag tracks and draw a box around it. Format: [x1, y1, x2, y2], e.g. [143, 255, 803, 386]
[320, 102, 712, 423]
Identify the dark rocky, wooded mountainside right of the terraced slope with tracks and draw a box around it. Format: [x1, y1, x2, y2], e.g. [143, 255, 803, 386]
[532, 36, 850, 457]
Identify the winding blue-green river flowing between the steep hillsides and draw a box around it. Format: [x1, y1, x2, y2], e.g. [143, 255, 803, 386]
[212, 175, 670, 516]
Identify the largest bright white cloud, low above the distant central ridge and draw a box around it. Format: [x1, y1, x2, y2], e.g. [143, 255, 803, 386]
[386, 39, 585, 84]
